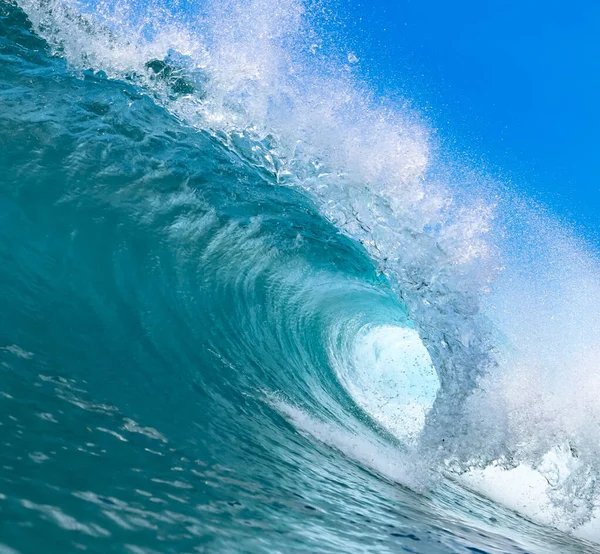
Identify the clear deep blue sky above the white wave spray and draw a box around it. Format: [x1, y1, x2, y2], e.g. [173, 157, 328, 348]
[346, 0, 600, 233]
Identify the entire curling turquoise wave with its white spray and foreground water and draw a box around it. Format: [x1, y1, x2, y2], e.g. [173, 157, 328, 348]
[0, 0, 600, 554]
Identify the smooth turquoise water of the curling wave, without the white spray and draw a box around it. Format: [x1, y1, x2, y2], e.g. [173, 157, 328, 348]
[0, 2, 596, 554]
